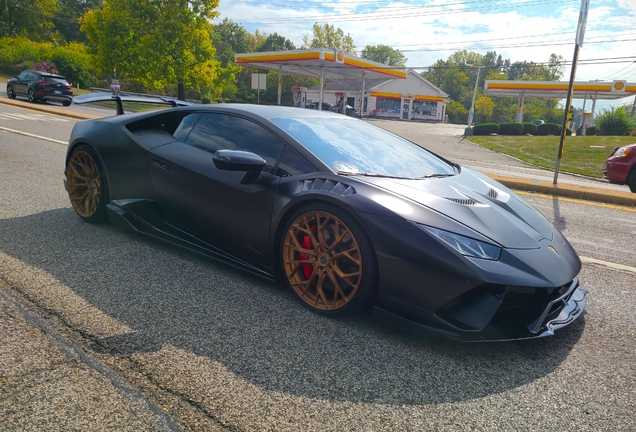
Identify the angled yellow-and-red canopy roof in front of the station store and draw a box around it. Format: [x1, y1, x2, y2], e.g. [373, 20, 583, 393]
[234, 48, 406, 80]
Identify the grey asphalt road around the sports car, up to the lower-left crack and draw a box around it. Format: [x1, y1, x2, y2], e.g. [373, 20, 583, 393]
[0, 102, 636, 431]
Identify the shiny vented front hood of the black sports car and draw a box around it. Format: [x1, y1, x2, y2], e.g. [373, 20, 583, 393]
[357, 167, 554, 249]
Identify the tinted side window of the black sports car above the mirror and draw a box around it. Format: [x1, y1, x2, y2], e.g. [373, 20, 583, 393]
[185, 114, 283, 173]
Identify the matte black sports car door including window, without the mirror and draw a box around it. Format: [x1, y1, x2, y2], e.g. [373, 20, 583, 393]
[149, 113, 284, 263]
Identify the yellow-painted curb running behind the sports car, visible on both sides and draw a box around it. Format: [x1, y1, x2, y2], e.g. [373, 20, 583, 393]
[0, 99, 636, 207]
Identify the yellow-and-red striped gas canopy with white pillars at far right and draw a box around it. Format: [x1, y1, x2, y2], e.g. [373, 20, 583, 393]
[484, 80, 636, 135]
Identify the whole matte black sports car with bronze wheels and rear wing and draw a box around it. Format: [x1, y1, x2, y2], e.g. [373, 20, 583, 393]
[65, 96, 586, 341]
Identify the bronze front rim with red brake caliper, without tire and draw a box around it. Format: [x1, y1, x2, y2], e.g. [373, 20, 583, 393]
[283, 211, 364, 311]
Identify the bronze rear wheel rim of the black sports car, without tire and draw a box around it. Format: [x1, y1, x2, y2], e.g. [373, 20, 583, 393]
[66, 150, 101, 218]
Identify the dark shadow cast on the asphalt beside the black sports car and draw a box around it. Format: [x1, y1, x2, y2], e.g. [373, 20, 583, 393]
[0, 209, 584, 405]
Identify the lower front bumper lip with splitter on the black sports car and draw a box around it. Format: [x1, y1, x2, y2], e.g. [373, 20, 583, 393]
[373, 279, 587, 342]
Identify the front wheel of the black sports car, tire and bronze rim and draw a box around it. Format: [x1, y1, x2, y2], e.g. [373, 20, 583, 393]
[280, 203, 378, 316]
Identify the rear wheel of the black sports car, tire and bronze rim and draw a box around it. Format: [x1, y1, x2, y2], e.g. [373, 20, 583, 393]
[66, 145, 109, 223]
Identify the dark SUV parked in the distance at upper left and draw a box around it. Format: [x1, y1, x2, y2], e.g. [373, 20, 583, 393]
[7, 70, 73, 106]
